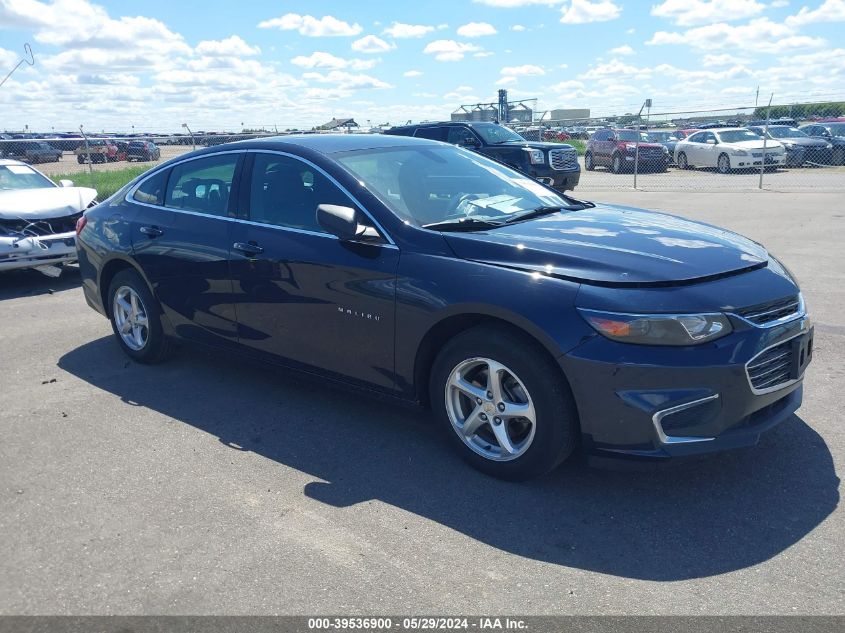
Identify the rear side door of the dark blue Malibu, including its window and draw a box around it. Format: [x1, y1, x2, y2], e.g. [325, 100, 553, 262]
[132, 152, 244, 344]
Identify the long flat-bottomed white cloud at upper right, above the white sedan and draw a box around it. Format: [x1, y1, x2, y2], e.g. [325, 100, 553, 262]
[646, 18, 825, 53]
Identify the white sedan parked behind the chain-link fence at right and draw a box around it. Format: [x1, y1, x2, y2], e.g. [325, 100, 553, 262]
[675, 127, 786, 174]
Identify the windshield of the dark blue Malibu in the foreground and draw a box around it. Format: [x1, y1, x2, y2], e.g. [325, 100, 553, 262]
[337, 147, 569, 226]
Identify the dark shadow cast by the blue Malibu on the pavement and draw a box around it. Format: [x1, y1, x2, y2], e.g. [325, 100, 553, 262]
[58, 338, 839, 581]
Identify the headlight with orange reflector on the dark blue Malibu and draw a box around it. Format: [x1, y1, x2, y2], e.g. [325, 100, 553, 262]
[578, 308, 733, 345]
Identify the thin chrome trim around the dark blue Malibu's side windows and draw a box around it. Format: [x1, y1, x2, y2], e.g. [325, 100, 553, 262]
[124, 149, 399, 250]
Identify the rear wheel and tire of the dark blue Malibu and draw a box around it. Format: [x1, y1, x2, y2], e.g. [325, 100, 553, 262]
[108, 270, 171, 363]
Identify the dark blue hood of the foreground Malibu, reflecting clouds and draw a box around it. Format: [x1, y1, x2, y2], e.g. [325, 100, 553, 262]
[443, 205, 769, 286]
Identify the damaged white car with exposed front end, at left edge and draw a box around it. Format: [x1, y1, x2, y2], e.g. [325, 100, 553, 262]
[0, 160, 97, 277]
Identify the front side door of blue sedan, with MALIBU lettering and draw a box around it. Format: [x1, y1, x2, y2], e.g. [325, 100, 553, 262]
[231, 152, 399, 388]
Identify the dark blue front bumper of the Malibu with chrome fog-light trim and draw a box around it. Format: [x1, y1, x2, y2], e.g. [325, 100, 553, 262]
[559, 317, 812, 459]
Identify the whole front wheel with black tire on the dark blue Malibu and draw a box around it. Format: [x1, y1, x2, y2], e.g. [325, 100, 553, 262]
[429, 326, 579, 481]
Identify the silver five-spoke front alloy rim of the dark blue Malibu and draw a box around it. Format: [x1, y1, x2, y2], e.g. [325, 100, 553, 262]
[445, 358, 537, 462]
